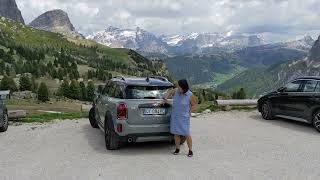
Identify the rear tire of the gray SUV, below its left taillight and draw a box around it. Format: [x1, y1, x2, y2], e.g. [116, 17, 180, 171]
[104, 117, 120, 150]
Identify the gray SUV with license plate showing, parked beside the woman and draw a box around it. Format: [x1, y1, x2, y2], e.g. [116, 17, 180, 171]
[89, 76, 181, 150]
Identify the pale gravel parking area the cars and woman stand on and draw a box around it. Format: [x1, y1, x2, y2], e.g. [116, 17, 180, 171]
[0, 111, 320, 180]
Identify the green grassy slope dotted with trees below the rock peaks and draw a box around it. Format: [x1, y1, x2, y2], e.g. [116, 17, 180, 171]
[0, 18, 168, 82]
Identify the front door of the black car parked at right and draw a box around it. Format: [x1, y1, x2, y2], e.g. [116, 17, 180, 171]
[272, 80, 303, 116]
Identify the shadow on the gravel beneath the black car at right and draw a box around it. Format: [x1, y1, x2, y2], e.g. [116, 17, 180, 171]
[250, 114, 319, 134]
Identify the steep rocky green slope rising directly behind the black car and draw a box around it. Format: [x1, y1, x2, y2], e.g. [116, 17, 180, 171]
[217, 36, 320, 97]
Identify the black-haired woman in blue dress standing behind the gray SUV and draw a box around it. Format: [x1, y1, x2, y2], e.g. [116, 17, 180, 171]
[164, 79, 196, 157]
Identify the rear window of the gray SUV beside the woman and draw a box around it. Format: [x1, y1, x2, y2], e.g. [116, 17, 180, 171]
[125, 86, 173, 99]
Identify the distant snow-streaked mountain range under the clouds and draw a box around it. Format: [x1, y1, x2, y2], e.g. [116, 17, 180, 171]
[87, 26, 265, 56]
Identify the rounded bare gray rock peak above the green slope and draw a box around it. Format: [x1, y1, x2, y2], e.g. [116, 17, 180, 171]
[29, 9, 83, 38]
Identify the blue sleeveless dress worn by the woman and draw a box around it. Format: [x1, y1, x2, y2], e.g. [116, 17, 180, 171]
[170, 90, 192, 136]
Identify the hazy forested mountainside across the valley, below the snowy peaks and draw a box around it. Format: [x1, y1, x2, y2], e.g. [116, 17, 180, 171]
[164, 37, 314, 88]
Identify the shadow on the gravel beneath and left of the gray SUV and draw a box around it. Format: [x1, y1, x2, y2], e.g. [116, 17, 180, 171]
[82, 123, 174, 156]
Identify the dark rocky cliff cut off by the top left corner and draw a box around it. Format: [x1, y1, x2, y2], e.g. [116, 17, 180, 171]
[0, 0, 24, 24]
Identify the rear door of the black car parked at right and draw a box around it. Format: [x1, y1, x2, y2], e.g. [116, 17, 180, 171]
[287, 80, 318, 119]
